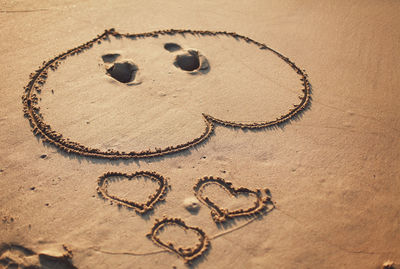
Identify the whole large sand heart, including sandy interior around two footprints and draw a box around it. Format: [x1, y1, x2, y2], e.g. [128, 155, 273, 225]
[22, 29, 311, 160]
